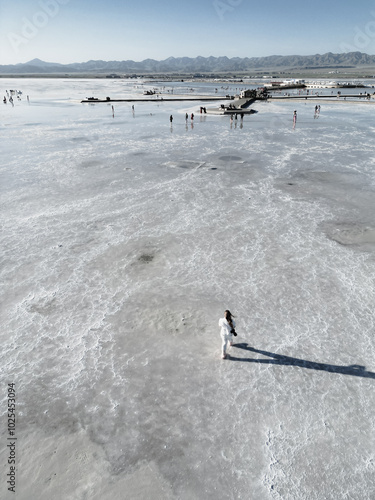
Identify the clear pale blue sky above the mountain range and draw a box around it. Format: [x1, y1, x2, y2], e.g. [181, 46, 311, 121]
[0, 0, 375, 64]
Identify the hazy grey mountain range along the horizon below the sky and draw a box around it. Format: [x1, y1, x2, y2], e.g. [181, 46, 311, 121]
[0, 52, 375, 75]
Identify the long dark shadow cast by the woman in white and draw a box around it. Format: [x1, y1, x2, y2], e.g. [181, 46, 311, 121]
[228, 343, 375, 379]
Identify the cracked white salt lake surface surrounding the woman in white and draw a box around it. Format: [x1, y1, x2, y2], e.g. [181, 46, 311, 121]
[0, 79, 375, 500]
